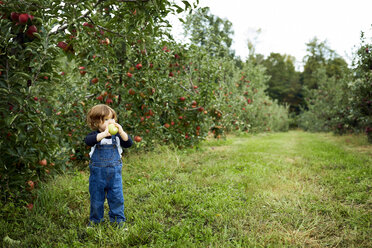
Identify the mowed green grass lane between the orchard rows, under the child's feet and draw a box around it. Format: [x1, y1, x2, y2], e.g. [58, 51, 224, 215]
[0, 131, 372, 247]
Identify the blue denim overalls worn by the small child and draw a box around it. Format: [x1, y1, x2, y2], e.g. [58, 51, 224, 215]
[89, 135, 126, 224]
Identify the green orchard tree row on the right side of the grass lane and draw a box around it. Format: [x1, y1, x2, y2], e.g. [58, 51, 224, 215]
[300, 32, 372, 142]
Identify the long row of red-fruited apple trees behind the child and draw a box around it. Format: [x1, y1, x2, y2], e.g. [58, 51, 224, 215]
[0, 0, 287, 207]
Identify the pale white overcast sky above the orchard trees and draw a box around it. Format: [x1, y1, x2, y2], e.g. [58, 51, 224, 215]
[170, 0, 372, 70]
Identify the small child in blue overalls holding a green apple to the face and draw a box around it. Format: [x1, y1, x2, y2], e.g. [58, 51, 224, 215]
[85, 104, 133, 226]
